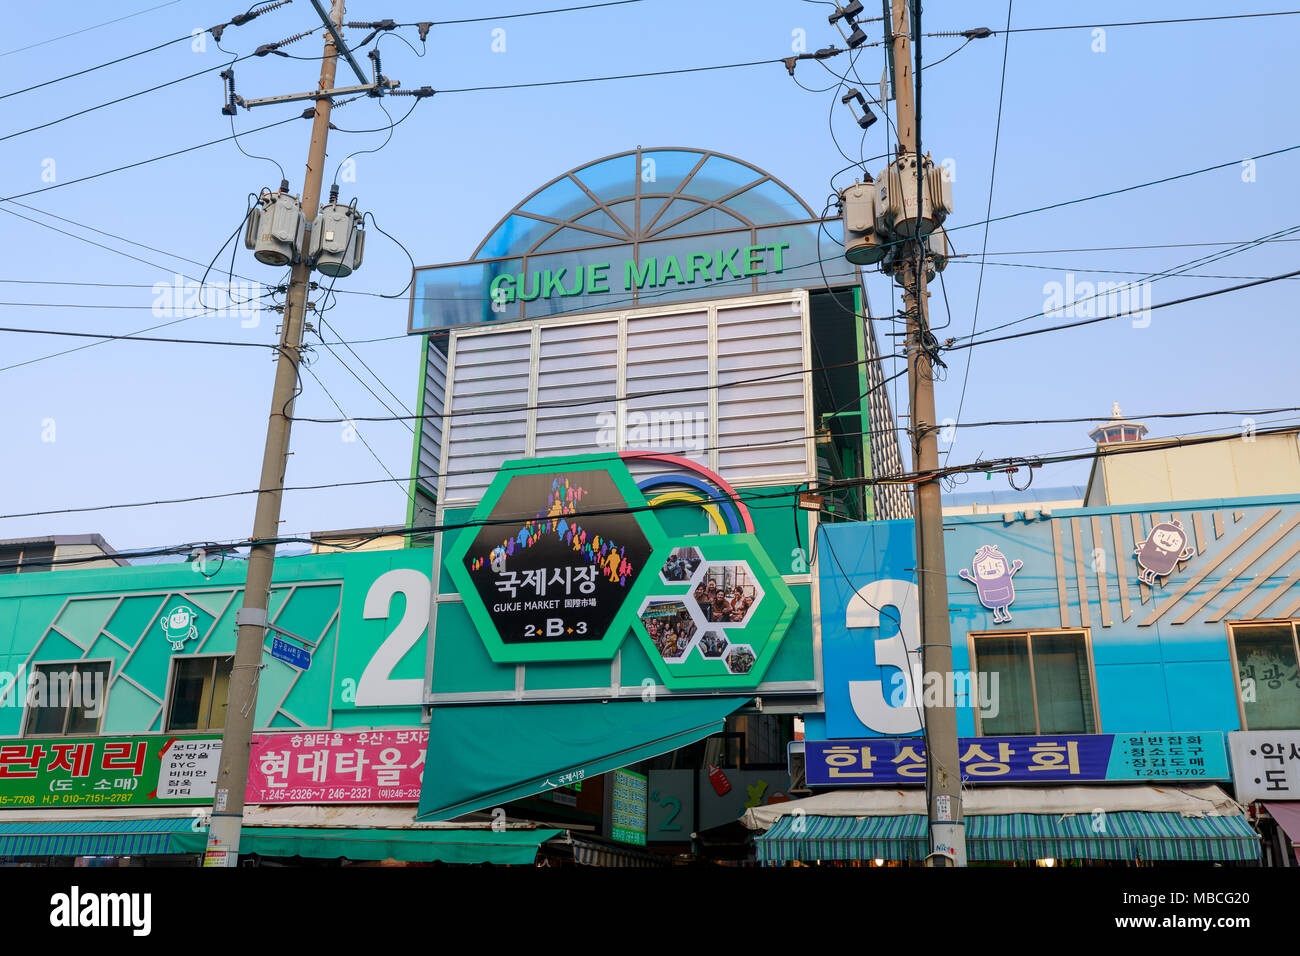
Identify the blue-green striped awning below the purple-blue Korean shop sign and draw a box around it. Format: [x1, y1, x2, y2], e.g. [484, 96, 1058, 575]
[755, 812, 1260, 864]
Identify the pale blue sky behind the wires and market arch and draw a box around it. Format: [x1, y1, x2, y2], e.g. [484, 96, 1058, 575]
[0, 0, 1300, 549]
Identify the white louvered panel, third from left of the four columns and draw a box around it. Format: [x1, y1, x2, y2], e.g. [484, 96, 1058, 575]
[623, 312, 712, 465]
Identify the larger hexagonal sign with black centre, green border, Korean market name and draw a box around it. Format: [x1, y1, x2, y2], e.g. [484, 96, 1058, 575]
[446, 455, 664, 663]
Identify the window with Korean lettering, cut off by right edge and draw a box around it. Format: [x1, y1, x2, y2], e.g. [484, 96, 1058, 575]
[1229, 620, 1300, 730]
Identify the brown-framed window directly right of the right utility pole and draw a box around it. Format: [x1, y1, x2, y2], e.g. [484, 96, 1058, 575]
[970, 631, 1097, 736]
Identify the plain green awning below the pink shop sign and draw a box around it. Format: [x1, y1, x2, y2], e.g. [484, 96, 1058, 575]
[176, 826, 564, 866]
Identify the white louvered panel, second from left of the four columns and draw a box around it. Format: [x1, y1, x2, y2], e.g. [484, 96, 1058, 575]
[533, 320, 619, 458]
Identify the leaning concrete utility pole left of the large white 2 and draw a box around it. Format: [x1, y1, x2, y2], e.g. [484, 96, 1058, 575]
[208, 0, 343, 866]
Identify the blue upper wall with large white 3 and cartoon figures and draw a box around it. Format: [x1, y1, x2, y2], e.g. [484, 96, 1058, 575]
[807, 496, 1300, 739]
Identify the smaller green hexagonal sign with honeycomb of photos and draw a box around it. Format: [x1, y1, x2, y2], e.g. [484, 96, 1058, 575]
[633, 535, 798, 691]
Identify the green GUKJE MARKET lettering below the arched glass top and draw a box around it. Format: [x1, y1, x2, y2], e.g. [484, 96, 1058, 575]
[489, 242, 790, 306]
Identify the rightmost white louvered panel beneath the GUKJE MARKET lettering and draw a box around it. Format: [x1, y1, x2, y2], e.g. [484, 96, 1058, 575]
[718, 302, 814, 485]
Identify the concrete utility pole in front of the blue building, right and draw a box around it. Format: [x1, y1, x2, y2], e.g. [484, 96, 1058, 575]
[891, 0, 966, 866]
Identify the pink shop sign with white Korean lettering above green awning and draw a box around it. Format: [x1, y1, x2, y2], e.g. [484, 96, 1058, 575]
[244, 730, 429, 804]
